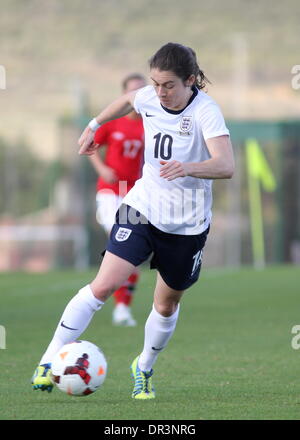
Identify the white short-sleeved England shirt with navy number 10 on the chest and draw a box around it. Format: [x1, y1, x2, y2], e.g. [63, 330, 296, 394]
[123, 86, 229, 235]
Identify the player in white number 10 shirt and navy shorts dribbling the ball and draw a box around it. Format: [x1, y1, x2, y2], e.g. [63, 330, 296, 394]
[33, 43, 234, 399]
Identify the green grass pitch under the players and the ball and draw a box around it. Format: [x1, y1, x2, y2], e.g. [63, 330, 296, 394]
[0, 266, 300, 420]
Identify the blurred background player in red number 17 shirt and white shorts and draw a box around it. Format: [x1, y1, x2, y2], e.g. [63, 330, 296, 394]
[90, 73, 146, 326]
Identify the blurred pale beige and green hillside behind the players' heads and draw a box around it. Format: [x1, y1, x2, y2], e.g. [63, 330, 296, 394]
[0, 0, 300, 158]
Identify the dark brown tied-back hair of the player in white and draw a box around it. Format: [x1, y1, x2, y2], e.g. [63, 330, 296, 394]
[149, 43, 210, 90]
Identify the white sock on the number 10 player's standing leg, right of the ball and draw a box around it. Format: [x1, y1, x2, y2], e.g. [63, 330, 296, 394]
[138, 304, 179, 371]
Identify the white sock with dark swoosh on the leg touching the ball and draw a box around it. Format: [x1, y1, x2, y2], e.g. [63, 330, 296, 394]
[40, 285, 104, 365]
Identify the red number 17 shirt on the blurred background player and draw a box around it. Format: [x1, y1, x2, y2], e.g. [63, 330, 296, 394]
[94, 116, 144, 196]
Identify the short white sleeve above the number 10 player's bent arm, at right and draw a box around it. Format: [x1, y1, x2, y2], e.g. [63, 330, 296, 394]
[200, 102, 229, 140]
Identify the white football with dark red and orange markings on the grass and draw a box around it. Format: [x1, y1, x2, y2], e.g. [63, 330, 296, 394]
[51, 341, 107, 396]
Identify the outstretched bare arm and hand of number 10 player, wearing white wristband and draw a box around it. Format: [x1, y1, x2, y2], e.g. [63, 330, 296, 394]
[78, 90, 137, 156]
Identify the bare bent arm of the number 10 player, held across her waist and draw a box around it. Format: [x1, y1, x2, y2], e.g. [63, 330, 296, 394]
[160, 135, 234, 180]
